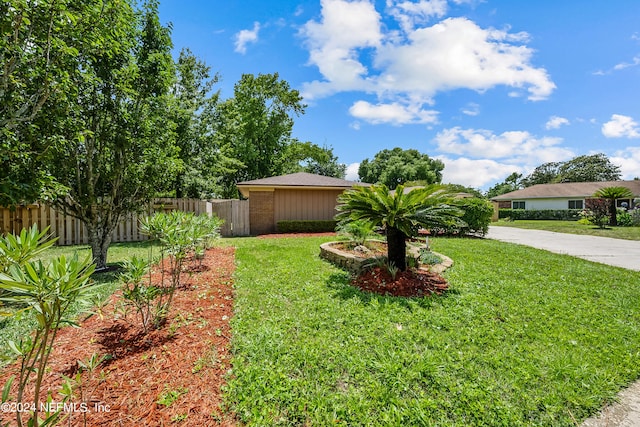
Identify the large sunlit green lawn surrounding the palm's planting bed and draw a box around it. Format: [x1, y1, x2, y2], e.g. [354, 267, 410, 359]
[227, 238, 640, 426]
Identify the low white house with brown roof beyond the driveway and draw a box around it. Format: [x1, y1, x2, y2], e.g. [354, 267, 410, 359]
[491, 181, 640, 210]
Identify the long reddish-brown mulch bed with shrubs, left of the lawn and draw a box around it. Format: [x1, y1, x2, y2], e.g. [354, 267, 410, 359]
[0, 248, 235, 426]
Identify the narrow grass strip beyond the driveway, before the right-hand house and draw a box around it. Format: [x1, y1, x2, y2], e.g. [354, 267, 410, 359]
[491, 220, 640, 240]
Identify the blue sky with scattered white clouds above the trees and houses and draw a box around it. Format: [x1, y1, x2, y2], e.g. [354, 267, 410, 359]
[160, 0, 640, 189]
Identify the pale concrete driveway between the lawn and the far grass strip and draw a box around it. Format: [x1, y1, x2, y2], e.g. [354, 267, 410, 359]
[485, 226, 640, 271]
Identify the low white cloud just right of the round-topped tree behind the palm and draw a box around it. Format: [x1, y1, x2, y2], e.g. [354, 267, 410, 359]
[436, 156, 522, 189]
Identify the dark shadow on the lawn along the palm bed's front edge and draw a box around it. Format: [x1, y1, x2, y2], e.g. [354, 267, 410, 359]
[325, 272, 459, 311]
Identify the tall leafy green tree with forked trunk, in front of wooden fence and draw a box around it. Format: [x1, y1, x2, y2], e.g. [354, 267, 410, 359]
[42, 1, 181, 268]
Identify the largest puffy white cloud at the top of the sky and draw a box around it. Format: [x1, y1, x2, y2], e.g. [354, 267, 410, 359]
[300, 0, 556, 125]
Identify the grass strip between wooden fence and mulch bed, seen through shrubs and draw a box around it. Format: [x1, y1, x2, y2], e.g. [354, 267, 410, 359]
[0, 242, 157, 366]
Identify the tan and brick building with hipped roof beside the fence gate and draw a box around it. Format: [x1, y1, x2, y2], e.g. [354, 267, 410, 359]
[237, 172, 369, 235]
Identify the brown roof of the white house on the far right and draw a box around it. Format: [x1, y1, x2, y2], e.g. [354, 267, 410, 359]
[491, 180, 640, 201]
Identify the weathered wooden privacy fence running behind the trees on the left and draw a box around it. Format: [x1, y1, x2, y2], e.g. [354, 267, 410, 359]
[0, 198, 249, 245]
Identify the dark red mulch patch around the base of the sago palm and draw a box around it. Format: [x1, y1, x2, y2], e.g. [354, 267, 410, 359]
[351, 267, 449, 297]
